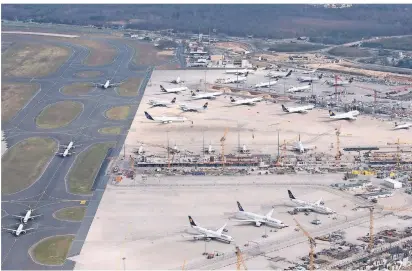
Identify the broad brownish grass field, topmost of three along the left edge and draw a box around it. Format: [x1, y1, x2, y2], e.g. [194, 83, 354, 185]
[1, 43, 70, 77]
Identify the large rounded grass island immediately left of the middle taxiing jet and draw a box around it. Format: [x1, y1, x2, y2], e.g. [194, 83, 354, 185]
[1, 137, 57, 194]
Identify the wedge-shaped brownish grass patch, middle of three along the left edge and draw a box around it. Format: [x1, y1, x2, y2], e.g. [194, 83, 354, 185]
[1, 83, 39, 122]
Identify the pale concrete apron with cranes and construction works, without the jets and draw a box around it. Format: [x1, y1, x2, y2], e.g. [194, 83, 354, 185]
[73, 69, 412, 270]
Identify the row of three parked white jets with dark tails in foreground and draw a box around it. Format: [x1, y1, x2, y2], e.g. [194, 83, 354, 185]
[188, 190, 336, 244]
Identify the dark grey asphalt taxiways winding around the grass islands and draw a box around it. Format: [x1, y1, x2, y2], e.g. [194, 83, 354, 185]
[1, 34, 162, 270]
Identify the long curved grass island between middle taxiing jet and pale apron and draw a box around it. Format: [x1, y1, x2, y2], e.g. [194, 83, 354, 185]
[68, 142, 114, 194]
